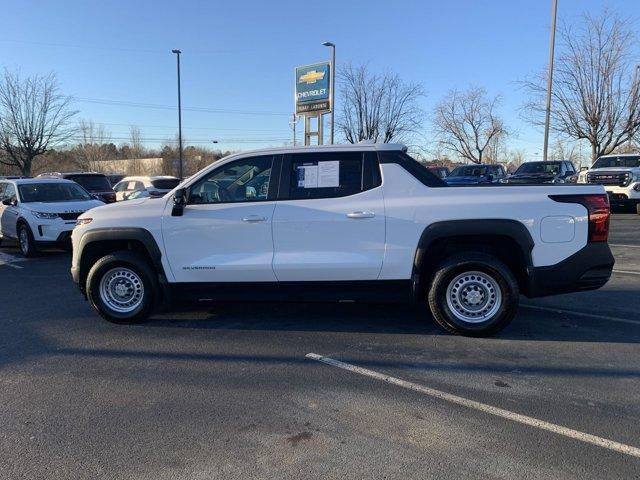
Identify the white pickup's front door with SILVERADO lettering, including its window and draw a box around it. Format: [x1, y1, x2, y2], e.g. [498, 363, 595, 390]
[162, 155, 279, 282]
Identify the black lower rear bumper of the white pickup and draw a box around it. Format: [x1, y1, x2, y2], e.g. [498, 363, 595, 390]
[523, 242, 615, 298]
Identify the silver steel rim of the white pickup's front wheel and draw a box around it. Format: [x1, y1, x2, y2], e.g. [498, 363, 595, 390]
[100, 267, 144, 313]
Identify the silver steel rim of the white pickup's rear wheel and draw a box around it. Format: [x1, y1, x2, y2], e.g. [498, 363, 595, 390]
[447, 271, 502, 323]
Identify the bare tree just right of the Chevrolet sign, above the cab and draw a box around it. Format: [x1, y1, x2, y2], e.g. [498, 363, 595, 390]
[337, 65, 424, 143]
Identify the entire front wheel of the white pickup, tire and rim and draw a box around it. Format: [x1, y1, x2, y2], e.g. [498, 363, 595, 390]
[87, 251, 158, 324]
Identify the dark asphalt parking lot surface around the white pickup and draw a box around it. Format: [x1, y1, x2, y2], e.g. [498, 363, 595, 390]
[0, 214, 640, 480]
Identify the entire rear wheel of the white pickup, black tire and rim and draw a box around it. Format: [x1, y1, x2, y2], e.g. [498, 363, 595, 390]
[427, 252, 519, 337]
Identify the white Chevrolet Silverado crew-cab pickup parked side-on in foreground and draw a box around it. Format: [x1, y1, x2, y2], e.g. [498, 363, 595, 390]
[71, 144, 614, 335]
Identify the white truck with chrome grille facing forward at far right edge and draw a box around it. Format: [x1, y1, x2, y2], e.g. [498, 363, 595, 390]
[578, 153, 640, 215]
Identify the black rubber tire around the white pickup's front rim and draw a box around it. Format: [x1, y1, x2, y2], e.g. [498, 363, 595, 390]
[86, 250, 159, 324]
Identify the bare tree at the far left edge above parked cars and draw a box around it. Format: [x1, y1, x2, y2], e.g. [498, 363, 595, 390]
[0, 69, 77, 175]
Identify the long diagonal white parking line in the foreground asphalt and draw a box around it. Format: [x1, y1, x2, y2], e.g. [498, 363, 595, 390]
[305, 353, 640, 458]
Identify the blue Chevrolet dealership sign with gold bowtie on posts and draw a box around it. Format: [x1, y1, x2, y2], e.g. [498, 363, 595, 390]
[296, 62, 332, 114]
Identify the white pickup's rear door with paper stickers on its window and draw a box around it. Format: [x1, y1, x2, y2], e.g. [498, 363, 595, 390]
[273, 152, 385, 281]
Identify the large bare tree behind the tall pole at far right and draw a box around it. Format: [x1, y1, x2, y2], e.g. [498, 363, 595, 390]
[523, 11, 640, 160]
